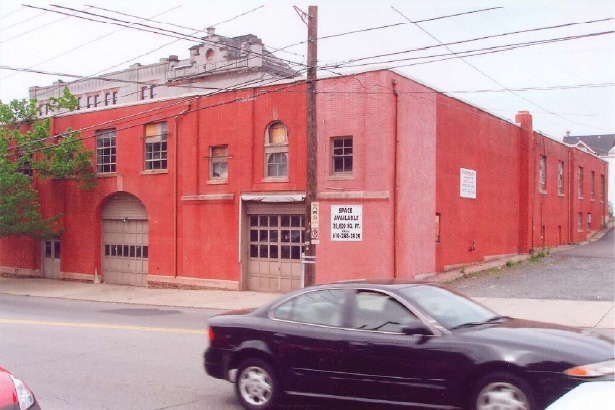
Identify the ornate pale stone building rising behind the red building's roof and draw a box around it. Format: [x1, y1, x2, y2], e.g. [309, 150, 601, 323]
[30, 28, 297, 116]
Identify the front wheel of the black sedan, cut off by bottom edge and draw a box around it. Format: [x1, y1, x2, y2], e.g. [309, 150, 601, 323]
[470, 372, 539, 410]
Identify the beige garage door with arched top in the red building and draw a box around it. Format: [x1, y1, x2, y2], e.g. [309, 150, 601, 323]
[102, 192, 149, 286]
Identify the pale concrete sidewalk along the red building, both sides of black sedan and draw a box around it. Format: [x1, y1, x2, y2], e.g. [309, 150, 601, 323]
[0, 225, 615, 331]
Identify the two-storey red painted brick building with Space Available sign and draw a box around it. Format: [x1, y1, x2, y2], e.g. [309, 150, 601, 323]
[0, 70, 608, 291]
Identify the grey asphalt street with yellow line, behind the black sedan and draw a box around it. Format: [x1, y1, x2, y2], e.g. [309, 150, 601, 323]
[0, 294, 370, 410]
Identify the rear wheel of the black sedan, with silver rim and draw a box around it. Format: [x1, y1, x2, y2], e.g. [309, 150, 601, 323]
[235, 359, 282, 410]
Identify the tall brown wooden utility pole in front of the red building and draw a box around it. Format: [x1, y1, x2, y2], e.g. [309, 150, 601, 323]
[304, 6, 319, 286]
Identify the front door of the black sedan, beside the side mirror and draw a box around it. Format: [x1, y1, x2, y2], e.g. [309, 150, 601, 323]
[342, 290, 465, 405]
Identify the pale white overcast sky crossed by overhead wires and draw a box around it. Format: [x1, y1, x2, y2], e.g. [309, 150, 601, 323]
[0, 0, 615, 140]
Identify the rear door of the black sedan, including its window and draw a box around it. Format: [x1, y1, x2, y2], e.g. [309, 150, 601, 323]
[270, 289, 347, 395]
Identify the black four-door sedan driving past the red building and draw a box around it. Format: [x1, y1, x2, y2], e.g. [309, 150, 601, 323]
[205, 280, 614, 410]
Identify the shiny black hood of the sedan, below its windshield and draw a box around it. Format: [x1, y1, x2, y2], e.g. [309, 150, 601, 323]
[464, 319, 614, 365]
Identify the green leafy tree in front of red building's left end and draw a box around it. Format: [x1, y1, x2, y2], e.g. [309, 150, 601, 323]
[0, 88, 96, 239]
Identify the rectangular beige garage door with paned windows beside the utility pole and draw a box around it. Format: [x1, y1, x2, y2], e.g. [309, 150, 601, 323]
[248, 214, 305, 292]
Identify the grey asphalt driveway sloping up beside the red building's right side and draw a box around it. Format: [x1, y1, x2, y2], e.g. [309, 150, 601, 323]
[448, 229, 615, 301]
